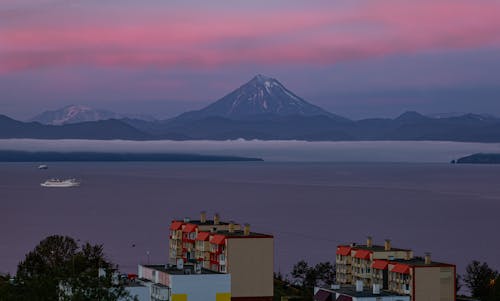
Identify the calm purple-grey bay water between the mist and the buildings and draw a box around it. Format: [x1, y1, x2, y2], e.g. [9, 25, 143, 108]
[0, 162, 500, 273]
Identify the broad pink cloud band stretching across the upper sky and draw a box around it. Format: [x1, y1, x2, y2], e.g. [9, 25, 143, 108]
[0, 0, 500, 73]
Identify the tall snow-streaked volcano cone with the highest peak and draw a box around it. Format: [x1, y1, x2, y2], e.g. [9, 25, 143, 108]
[174, 74, 344, 119]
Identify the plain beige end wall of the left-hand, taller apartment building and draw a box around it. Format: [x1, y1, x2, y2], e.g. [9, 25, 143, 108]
[227, 237, 274, 299]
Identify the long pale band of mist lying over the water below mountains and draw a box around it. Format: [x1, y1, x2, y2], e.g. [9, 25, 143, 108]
[0, 139, 500, 162]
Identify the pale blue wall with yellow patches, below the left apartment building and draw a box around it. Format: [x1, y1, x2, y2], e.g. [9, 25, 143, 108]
[170, 274, 231, 301]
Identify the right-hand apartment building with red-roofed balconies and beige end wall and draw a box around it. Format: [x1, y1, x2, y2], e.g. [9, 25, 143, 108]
[336, 237, 456, 301]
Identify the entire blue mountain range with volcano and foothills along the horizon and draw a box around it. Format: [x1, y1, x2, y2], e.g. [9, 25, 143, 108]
[0, 75, 500, 142]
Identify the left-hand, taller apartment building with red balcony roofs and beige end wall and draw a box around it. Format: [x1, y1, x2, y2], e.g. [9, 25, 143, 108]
[169, 213, 274, 301]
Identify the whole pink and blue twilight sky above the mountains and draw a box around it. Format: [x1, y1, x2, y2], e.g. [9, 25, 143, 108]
[0, 0, 500, 119]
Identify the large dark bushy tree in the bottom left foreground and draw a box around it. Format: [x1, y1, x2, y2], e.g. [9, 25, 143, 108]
[14, 235, 135, 301]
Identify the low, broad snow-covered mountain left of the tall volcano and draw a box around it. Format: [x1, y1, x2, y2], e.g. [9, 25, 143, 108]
[30, 105, 123, 125]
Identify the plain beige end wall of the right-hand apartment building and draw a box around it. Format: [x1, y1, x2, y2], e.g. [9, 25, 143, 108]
[414, 267, 455, 301]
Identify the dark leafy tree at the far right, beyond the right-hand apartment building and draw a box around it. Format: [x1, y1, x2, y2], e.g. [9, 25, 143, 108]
[463, 260, 498, 300]
